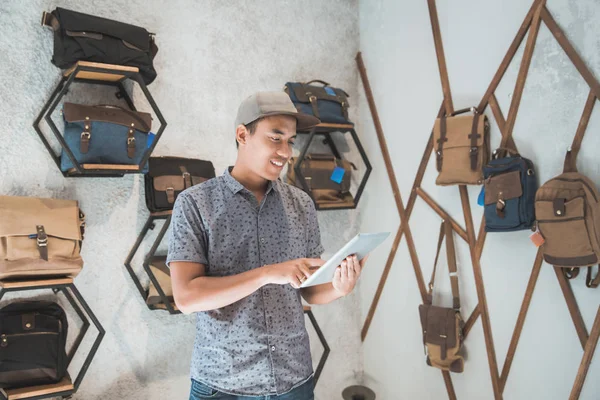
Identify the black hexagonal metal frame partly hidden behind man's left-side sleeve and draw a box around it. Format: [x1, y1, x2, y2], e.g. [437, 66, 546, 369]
[124, 213, 181, 314]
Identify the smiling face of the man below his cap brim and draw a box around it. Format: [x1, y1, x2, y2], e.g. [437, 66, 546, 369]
[243, 115, 296, 181]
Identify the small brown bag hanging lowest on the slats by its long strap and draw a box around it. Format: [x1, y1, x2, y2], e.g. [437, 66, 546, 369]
[419, 221, 464, 372]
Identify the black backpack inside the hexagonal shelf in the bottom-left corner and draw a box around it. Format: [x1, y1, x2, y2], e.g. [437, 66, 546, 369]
[0, 301, 68, 388]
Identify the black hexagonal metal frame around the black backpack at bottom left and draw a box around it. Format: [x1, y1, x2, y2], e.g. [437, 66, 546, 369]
[0, 283, 105, 400]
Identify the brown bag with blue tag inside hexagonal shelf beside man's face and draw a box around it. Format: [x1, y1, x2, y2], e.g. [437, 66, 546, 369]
[286, 153, 356, 204]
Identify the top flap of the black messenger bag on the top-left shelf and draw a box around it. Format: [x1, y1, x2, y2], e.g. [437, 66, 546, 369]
[53, 7, 150, 51]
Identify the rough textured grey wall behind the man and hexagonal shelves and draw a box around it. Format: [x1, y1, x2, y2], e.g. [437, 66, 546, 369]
[0, 0, 362, 400]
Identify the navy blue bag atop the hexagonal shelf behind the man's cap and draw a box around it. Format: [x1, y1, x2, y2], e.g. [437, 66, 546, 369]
[284, 79, 354, 125]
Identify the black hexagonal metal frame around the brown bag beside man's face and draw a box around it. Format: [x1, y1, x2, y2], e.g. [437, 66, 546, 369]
[294, 126, 373, 211]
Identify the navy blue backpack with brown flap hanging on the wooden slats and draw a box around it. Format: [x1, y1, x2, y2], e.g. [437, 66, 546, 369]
[483, 149, 538, 232]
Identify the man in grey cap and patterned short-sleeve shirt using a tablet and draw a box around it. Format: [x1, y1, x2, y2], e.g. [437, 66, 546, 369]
[167, 92, 365, 400]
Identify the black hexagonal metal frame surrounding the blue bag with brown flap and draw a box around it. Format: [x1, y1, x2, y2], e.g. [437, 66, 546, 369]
[33, 64, 167, 177]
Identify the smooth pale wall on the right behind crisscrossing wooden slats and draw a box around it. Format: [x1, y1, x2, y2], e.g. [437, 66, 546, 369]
[359, 0, 600, 400]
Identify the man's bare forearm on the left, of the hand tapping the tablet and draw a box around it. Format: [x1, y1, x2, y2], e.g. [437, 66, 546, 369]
[175, 268, 267, 314]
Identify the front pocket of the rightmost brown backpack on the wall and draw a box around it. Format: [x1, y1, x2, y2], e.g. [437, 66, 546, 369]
[535, 197, 597, 267]
